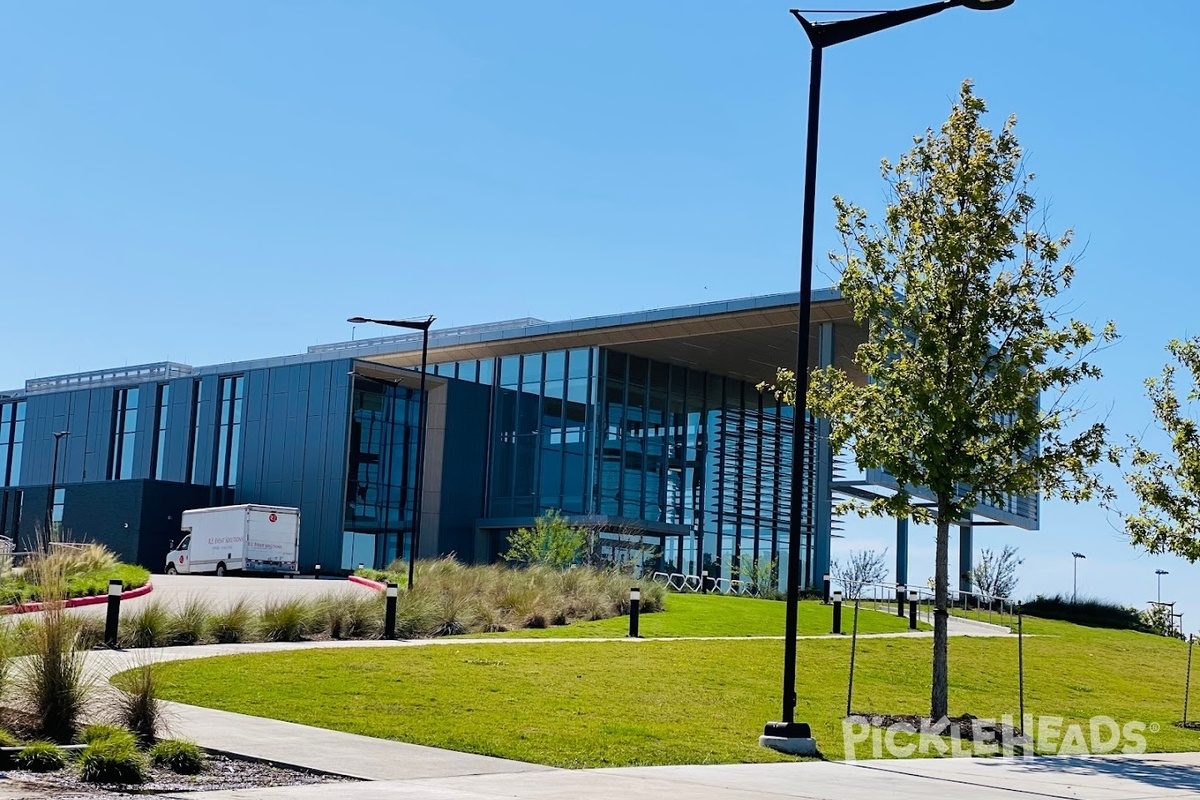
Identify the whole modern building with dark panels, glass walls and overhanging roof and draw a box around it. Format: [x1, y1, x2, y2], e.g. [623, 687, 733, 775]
[0, 291, 1037, 587]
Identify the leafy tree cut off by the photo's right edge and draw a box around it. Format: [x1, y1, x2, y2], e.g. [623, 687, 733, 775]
[1124, 337, 1200, 564]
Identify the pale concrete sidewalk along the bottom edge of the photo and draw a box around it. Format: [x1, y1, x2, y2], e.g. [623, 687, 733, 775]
[167, 753, 1200, 800]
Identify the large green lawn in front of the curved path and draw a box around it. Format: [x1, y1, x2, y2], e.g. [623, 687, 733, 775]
[142, 597, 1200, 768]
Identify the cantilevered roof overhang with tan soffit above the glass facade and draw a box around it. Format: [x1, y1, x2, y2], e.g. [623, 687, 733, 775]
[310, 289, 864, 383]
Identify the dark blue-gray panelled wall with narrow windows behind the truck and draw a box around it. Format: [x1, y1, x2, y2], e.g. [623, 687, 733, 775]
[10, 359, 353, 571]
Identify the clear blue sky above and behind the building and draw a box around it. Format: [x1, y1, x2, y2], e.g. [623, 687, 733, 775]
[0, 0, 1200, 628]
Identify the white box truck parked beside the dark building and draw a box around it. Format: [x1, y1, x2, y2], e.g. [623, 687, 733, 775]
[166, 505, 300, 576]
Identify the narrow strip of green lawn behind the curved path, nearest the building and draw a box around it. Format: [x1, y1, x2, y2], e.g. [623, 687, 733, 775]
[475, 594, 929, 638]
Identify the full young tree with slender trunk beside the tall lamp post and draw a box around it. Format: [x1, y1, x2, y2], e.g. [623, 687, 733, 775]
[775, 82, 1116, 718]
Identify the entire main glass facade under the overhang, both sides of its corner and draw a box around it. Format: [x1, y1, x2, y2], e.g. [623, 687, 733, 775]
[431, 348, 814, 585]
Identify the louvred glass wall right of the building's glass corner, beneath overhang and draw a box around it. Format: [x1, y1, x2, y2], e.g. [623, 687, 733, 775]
[596, 350, 812, 583]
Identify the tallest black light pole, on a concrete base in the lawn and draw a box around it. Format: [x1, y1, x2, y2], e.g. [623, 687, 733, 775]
[761, 0, 1014, 754]
